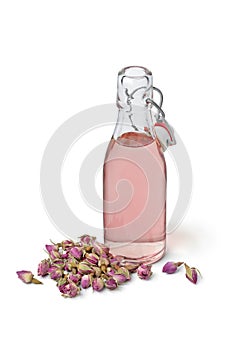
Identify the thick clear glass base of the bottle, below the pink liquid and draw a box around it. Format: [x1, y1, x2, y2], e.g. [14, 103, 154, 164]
[105, 240, 166, 265]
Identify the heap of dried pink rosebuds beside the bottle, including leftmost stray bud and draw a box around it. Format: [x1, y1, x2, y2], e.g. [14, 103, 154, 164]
[17, 235, 152, 298]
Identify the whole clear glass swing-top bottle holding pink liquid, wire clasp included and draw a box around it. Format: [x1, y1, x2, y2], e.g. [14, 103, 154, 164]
[103, 66, 175, 264]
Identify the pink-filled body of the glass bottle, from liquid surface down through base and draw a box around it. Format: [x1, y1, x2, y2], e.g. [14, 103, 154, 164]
[104, 132, 166, 263]
